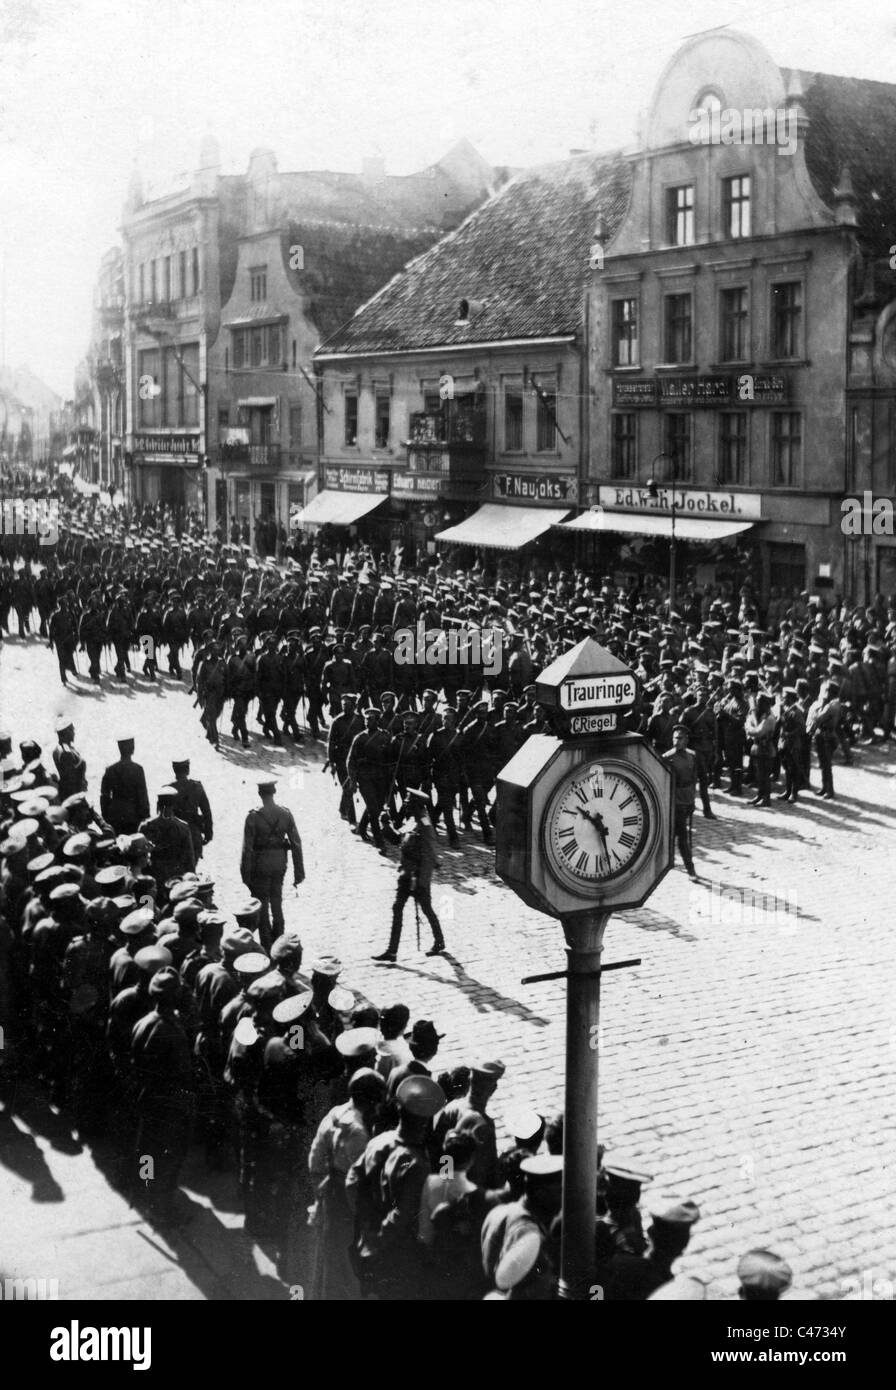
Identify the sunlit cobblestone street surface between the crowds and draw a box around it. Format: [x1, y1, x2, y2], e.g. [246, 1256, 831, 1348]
[0, 638, 896, 1298]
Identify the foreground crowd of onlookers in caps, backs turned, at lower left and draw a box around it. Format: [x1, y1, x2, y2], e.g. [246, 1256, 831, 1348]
[0, 719, 792, 1301]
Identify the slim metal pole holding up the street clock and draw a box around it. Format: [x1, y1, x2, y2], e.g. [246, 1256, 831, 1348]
[560, 912, 610, 1300]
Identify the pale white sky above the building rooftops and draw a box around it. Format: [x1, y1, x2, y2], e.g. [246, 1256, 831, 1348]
[0, 0, 896, 396]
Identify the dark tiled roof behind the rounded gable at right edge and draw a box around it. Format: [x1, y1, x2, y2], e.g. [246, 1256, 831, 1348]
[800, 72, 896, 254]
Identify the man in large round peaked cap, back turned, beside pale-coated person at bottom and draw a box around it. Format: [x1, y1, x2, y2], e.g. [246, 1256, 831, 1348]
[346, 1076, 445, 1301]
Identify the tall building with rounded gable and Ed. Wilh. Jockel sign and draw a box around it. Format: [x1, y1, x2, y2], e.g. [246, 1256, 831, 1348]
[583, 31, 896, 599]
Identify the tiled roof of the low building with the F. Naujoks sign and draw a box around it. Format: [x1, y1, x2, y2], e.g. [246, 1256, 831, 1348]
[318, 154, 631, 353]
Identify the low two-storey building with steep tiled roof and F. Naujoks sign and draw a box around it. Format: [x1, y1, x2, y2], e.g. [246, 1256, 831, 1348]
[312, 154, 629, 550]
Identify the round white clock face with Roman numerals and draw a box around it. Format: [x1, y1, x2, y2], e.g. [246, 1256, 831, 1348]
[543, 762, 653, 890]
